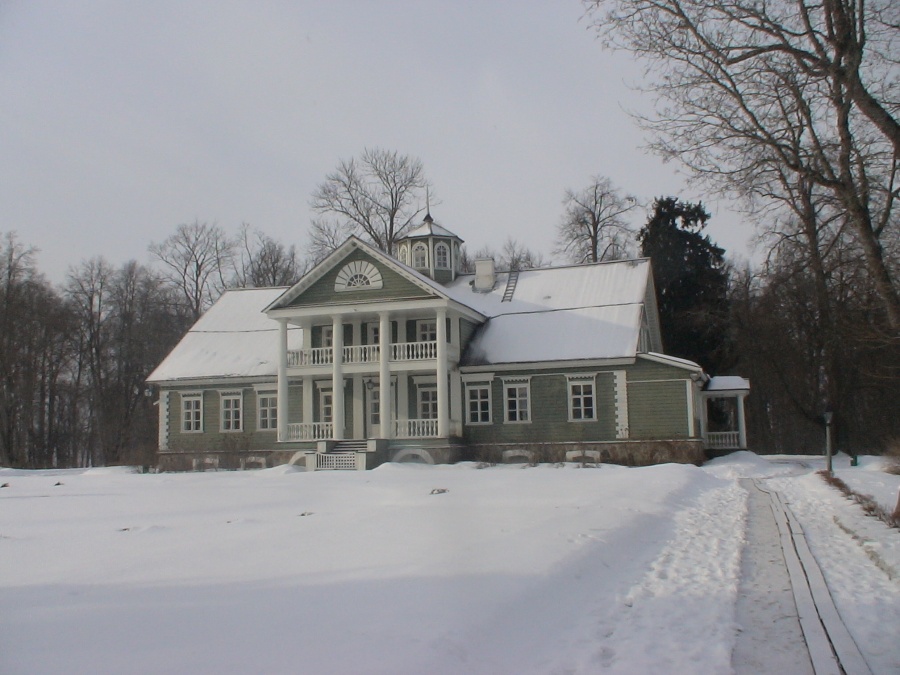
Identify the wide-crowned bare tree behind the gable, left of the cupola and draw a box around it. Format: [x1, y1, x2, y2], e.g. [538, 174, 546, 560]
[310, 148, 428, 257]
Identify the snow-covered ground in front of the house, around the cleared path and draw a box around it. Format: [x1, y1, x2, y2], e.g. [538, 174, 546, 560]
[0, 453, 900, 674]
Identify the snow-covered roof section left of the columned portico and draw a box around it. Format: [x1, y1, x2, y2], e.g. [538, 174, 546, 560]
[147, 288, 302, 382]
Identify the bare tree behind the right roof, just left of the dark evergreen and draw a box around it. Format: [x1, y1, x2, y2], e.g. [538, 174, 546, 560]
[556, 176, 637, 263]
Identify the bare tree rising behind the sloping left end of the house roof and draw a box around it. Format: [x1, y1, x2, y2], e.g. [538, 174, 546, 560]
[150, 220, 235, 321]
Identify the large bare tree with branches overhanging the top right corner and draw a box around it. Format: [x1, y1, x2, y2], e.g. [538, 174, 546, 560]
[587, 0, 900, 332]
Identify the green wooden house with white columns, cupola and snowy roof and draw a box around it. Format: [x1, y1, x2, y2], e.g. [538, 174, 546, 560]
[148, 216, 749, 470]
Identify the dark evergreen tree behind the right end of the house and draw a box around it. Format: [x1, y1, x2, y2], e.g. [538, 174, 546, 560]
[638, 197, 731, 374]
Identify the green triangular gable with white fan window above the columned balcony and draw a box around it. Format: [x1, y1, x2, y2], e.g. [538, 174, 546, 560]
[283, 247, 435, 307]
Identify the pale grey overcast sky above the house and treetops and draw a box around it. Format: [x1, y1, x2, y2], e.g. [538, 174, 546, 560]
[0, 0, 752, 282]
